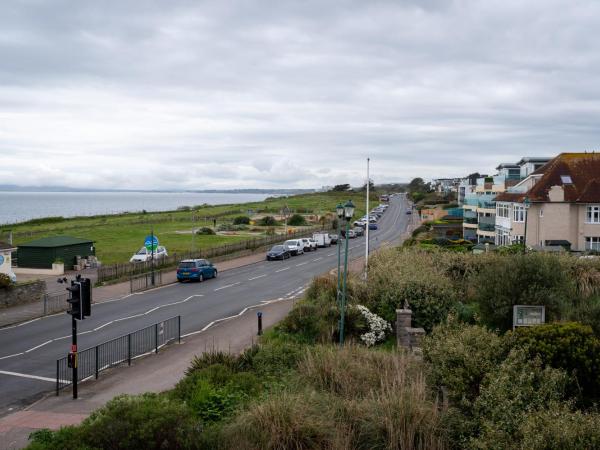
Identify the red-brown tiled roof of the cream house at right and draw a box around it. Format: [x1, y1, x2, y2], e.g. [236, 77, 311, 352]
[496, 153, 600, 203]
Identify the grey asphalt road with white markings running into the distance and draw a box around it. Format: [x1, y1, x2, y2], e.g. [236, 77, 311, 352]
[0, 196, 411, 416]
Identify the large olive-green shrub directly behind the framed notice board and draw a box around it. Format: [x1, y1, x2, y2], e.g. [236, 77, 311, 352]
[474, 253, 576, 330]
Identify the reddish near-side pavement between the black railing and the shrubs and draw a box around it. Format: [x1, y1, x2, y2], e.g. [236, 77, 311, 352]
[0, 300, 294, 450]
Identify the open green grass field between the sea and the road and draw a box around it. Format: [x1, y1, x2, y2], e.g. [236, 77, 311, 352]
[0, 192, 377, 264]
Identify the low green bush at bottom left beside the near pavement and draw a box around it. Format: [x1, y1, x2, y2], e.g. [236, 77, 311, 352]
[30, 394, 200, 450]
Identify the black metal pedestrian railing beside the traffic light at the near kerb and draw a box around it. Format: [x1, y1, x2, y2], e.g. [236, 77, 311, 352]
[56, 316, 181, 395]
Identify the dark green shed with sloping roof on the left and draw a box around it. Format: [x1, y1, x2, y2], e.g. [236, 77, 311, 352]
[17, 236, 96, 269]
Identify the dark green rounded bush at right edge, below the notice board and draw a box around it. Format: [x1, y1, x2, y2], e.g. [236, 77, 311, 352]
[511, 322, 600, 403]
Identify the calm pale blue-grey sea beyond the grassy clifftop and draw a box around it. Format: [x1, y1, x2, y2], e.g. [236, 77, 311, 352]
[0, 191, 276, 225]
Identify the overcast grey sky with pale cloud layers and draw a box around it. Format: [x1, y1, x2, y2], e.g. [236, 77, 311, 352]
[0, 0, 600, 189]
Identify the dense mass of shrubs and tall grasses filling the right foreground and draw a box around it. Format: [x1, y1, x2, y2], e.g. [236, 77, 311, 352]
[29, 247, 600, 449]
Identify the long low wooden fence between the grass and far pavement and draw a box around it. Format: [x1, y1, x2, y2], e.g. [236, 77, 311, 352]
[98, 227, 320, 283]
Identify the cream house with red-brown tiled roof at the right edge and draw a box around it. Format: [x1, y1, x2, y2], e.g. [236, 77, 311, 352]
[495, 153, 600, 251]
